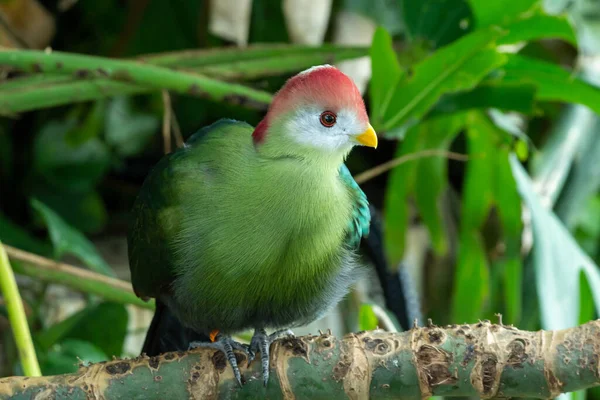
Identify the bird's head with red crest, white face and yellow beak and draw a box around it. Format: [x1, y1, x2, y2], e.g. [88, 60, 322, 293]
[252, 65, 377, 161]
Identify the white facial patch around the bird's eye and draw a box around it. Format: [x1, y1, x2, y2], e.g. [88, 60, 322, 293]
[285, 107, 365, 151]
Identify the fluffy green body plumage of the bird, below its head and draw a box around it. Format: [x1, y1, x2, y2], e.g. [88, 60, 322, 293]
[129, 120, 370, 333]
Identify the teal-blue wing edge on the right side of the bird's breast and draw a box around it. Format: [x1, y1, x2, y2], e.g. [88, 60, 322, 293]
[340, 164, 371, 248]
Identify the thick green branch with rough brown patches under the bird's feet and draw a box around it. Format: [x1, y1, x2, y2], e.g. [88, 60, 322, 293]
[0, 320, 600, 400]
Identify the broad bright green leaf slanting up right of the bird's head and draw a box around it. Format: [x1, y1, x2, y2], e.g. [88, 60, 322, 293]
[383, 29, 506, 134]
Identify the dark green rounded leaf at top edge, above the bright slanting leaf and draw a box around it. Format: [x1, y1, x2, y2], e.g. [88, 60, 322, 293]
[400, 0, 473, 47]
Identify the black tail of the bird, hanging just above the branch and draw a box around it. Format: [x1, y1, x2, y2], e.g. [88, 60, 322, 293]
[142, 299, 210, 357]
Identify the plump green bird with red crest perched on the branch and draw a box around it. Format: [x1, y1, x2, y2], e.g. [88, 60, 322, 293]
[128, 65, 377, 385]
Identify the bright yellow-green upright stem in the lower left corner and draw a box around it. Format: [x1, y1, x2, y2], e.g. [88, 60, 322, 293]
[0, 242, 42, 376]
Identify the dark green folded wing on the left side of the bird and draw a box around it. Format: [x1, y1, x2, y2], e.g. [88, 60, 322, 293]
[128, 119, 251, 298]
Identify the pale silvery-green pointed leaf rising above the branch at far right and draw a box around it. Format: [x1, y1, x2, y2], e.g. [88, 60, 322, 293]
[510, 157, 600, 329]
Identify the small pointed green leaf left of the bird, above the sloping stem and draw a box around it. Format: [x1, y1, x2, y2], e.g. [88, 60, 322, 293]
[31, 199, 115, 276]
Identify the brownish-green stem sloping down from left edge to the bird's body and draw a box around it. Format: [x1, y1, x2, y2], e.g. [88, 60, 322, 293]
[4, 245, 154, 310]
